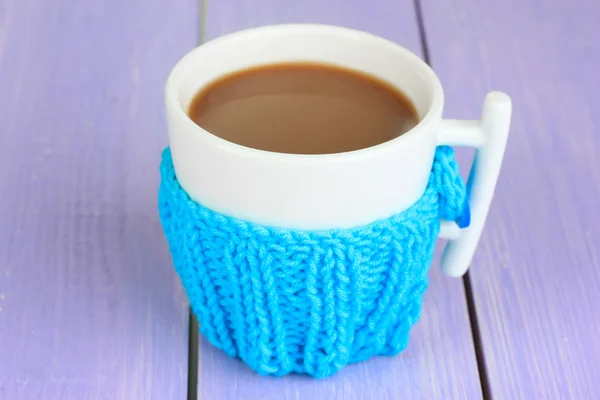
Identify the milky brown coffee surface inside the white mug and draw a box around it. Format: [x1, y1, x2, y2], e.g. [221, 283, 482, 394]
[188, 63, 419, 154]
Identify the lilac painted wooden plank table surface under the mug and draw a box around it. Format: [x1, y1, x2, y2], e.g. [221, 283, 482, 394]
[0, 0, 600, 400]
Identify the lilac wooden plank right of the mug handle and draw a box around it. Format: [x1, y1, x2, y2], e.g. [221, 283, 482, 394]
[423, 0, 600, 399]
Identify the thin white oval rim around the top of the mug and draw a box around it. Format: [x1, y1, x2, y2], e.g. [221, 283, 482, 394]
[165, 24, 444, 162]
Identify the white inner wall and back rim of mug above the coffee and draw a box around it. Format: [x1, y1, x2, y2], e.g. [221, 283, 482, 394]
[167, 25, 443, 121]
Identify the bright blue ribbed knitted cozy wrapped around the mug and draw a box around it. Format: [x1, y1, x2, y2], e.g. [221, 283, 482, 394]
[159, 146, 466, 377]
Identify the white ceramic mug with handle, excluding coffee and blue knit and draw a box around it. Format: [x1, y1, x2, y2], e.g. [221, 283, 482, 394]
[166, 24, 511, 276]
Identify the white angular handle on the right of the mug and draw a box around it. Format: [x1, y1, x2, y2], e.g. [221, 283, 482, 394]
[438, 92, 512, 277]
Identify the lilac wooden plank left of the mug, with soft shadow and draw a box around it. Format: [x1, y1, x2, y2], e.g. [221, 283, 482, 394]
[0, 0, 197, 400]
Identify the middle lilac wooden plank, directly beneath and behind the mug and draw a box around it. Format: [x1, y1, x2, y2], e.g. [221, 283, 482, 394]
[198, 0, 481, 400]
